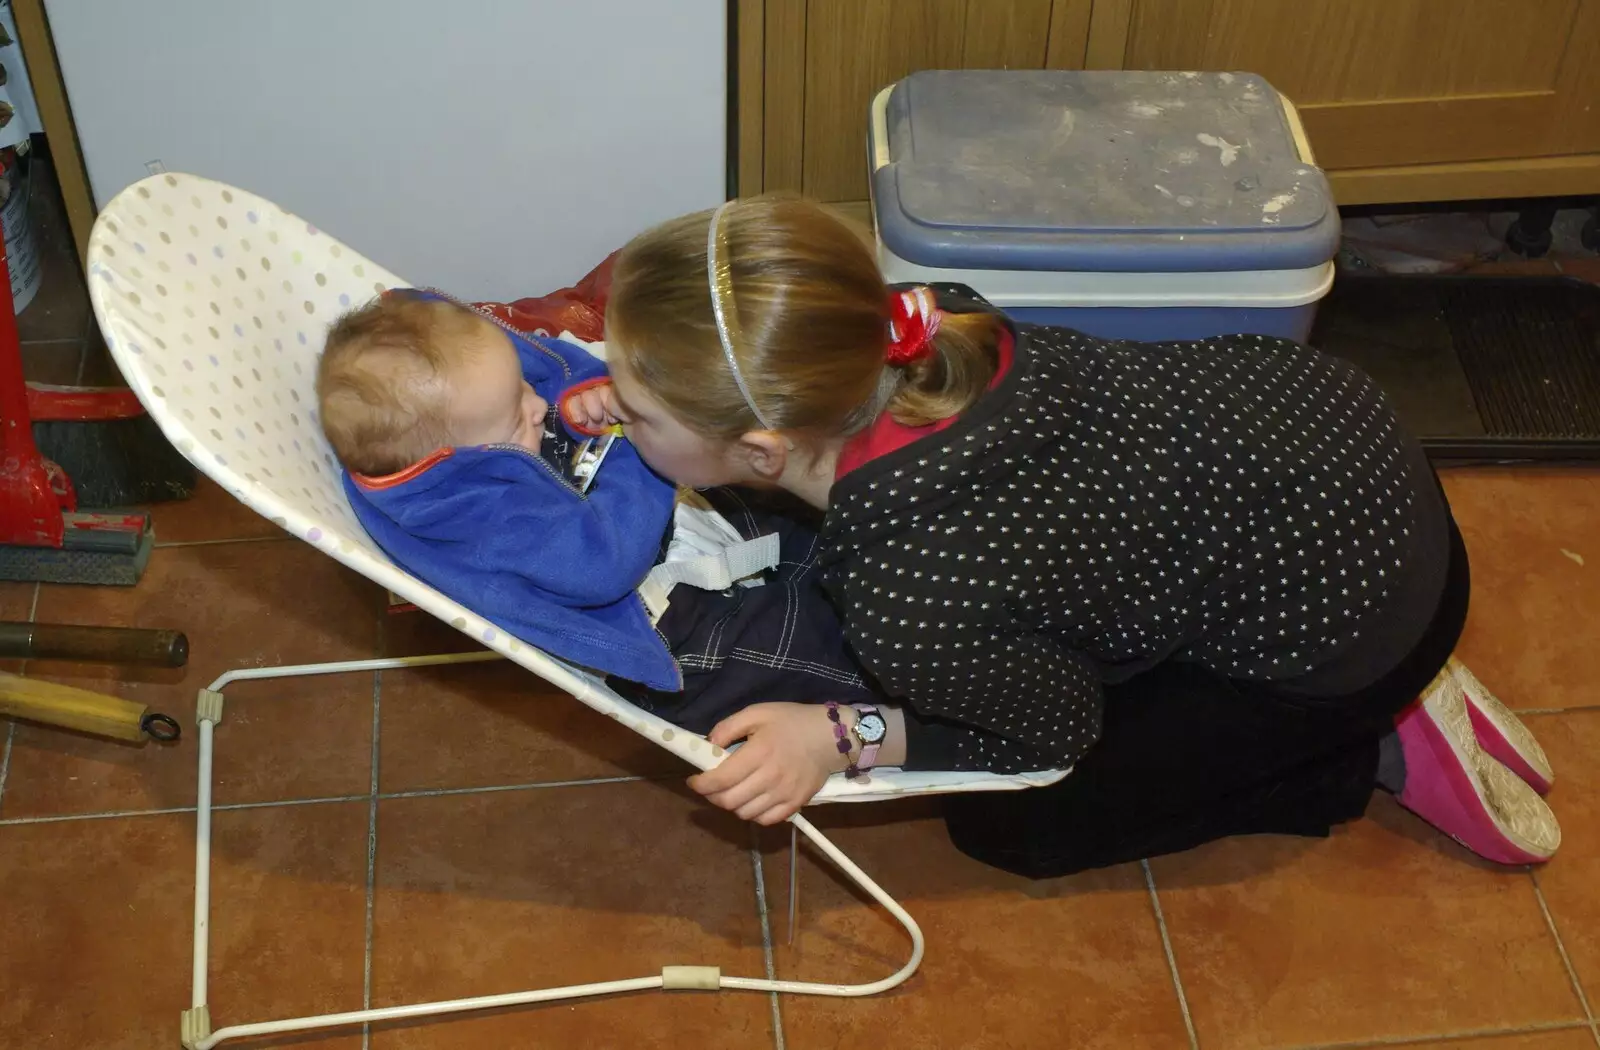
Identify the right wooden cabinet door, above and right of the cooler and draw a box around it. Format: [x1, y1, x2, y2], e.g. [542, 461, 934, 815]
[1120, 0, 1600, 171]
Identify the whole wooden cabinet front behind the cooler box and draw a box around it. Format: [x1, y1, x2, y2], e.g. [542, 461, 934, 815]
[738, 0, 1600, 203]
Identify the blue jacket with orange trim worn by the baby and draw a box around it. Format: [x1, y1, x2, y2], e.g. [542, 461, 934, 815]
[344, 293, 683, 691]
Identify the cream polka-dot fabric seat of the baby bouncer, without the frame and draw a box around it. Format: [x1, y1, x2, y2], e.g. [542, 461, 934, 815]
[88, 173, 1062, 802]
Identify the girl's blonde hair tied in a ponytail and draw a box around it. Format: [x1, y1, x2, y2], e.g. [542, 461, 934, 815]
[606, 197, 1000, 440]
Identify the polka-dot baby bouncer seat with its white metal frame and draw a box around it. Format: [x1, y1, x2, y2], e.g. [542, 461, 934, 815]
[88, 174, 1066, 1050]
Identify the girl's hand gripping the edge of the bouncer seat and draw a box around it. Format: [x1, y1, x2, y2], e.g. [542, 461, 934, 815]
[690, 704, 854, 824]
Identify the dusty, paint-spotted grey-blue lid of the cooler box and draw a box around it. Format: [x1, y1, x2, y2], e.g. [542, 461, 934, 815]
[872, 70, 1339, 272]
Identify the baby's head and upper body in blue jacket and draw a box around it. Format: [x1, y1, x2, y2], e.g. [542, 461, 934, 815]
[317, 290, 682, 690]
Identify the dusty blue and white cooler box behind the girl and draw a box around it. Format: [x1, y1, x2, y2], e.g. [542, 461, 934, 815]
[869, 70, 1339, 341]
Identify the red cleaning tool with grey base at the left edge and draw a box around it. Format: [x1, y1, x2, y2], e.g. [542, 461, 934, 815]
[0, 212, 155, 584]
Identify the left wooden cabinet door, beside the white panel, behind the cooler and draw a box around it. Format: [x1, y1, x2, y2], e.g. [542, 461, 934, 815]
[738, 0, 1093, 202]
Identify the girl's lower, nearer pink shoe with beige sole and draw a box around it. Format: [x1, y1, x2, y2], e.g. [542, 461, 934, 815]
[1395, 674, 1562, 864]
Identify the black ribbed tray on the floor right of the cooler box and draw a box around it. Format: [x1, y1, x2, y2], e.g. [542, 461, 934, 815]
[1312, 277, 1600, 458]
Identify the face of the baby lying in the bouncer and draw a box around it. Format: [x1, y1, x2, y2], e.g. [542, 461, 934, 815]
[446, 319, 549, 451]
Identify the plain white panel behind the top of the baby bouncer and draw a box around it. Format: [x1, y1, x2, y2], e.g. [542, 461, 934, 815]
[46, 0, 726, 299]
